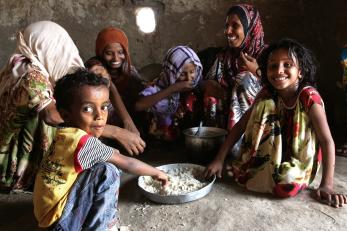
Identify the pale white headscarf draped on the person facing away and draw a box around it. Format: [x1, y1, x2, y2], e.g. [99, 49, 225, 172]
[0, 21, 84, 100]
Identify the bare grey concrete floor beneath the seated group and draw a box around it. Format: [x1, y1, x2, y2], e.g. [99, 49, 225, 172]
[0, 145, 347, 231]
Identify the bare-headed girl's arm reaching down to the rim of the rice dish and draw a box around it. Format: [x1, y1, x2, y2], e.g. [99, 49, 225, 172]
[204, 107, 252, 178]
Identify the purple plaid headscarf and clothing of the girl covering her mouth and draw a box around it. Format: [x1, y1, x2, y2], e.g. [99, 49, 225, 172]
[140, 46, 202, 139]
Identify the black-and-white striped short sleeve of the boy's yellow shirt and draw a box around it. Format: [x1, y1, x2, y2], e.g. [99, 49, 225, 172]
[75, 136, 119, 170]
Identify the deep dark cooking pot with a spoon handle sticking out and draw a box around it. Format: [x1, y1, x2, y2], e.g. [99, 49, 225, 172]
[183, 127, 228, 164]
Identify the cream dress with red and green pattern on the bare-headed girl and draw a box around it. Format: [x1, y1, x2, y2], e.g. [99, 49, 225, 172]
[231, 87, 324, 197]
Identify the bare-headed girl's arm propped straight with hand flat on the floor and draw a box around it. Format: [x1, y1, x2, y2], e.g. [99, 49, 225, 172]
[309, 104, 347, 207]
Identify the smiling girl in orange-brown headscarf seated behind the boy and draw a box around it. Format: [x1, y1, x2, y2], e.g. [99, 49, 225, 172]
[87, 27, 145, 134]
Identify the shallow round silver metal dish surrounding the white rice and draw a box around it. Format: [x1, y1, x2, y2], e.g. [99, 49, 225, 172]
[137, 163, 216, 204]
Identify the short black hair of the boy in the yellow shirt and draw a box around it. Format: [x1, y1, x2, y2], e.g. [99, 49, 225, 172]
[54, 68, 108, 110]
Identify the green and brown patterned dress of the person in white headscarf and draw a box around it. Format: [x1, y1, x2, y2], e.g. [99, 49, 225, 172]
[0, 67, 55, 191]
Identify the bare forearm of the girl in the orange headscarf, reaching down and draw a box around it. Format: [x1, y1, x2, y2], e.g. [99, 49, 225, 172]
[110, 81, 140, 135]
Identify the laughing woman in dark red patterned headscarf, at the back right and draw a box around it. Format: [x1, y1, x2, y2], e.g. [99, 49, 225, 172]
[203, 4, 265, 129]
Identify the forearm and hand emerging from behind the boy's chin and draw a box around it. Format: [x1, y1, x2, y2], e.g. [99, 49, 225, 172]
[102, 124, 146, 155]
